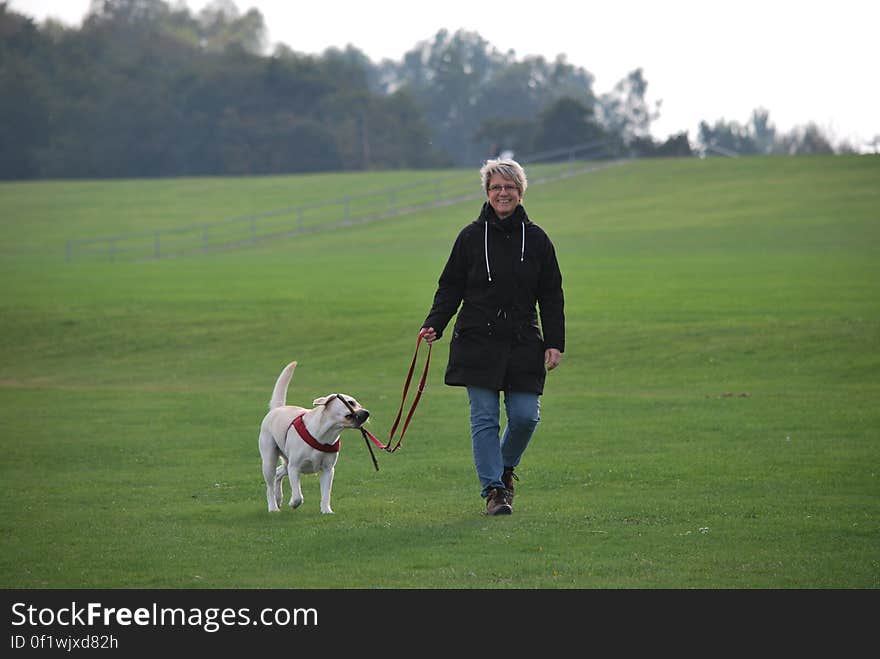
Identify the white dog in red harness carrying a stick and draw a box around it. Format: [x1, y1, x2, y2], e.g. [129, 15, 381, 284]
[260, 362, 370, 513]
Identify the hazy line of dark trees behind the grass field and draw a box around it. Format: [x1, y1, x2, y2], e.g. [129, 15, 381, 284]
[0, 0, 852, 179]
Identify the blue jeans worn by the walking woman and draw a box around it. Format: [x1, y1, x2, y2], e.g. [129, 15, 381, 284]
[467, 387, 541, 497]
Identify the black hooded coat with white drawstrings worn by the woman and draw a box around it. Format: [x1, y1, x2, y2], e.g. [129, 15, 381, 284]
[422, 202, 565, 394]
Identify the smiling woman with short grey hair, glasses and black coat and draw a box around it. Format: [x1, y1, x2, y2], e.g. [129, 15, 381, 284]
[422, 159, 565, 515]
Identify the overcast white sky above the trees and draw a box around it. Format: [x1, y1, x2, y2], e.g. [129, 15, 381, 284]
[10, 0, 880, 147]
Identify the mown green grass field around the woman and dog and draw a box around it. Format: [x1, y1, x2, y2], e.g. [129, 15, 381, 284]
[0, 156, 880, 589]
